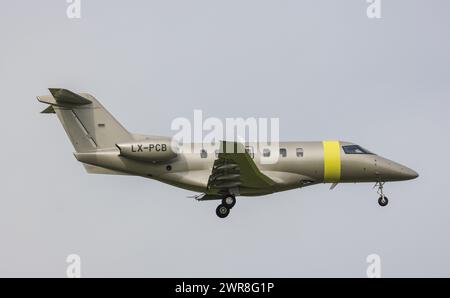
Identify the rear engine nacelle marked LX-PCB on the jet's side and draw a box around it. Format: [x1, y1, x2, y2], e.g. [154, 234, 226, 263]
[117, 140, 177, 162]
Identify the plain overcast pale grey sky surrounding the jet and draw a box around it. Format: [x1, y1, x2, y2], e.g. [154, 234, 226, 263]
[0, 0, 450, 277]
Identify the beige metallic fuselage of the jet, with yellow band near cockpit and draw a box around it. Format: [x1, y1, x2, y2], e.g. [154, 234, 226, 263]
[76, 141, 418, 196]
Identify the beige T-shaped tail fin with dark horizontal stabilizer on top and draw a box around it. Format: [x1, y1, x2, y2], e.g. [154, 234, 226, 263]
[37, 88, 133, 152]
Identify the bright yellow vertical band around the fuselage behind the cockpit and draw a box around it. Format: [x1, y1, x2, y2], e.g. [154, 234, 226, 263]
[323, 141, 341, 182]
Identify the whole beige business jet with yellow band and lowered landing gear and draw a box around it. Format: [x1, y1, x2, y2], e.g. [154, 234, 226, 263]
[37, 89, 418, 218]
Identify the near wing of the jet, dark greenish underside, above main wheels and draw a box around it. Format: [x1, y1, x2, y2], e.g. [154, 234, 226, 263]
[208, 141, 275, 193]
